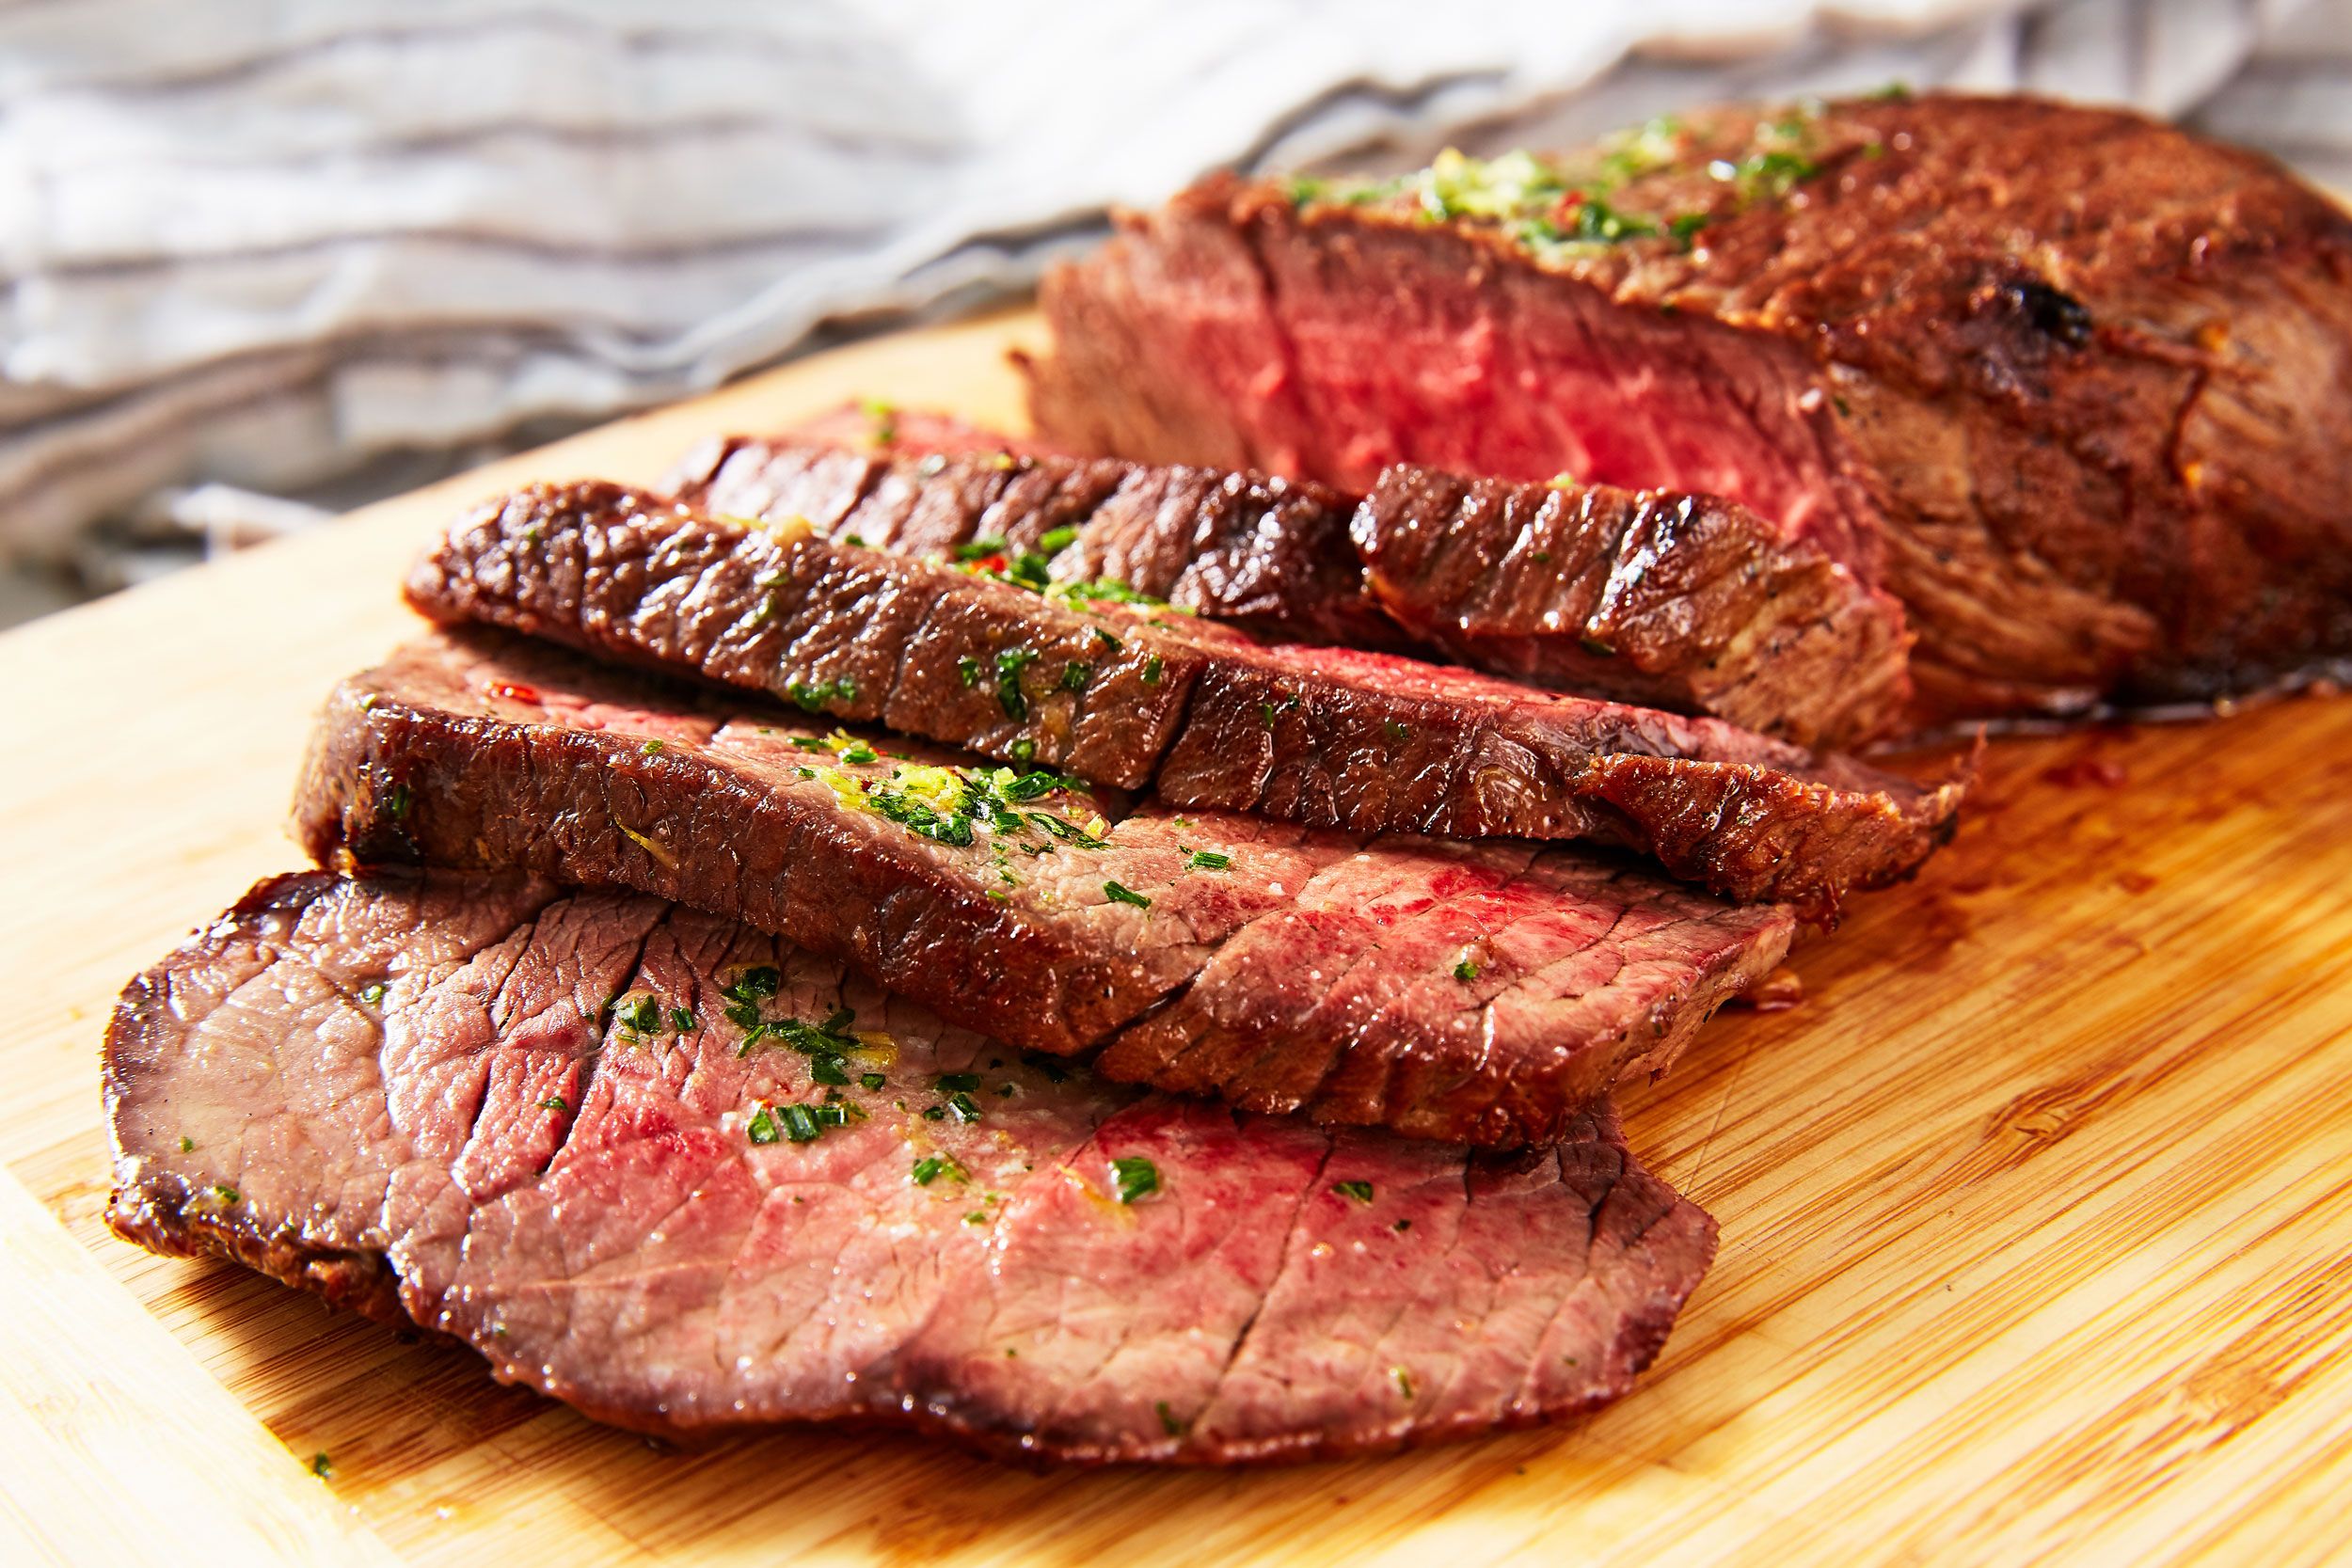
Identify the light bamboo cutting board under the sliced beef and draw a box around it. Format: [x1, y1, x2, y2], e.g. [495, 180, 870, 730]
[0, 317, 2352, 1568]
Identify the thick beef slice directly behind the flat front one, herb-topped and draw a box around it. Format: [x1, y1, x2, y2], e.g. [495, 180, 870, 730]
[296, 632, 1795, 1145]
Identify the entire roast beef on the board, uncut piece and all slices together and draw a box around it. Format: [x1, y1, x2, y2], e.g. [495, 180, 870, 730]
[166, 101, 2352, 1463]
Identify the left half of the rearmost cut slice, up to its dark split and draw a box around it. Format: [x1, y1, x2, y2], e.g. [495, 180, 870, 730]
[663, 419, 1411, 651]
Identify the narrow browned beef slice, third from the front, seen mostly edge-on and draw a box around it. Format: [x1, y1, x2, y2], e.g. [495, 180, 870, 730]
[409, 482, 1964, 919]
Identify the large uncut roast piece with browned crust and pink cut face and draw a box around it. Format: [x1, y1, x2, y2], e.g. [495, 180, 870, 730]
[1033, 96, 2352, 720]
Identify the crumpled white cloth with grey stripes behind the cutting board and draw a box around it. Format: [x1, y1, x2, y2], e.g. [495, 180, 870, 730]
[0, 0, 2352, 557]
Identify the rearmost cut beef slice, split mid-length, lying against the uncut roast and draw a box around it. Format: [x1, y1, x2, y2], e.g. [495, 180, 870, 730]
[666, 416, 1910, 745]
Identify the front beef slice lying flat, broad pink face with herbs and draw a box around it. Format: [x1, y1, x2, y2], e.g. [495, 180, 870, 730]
[106, 875, 1715, 1465]
